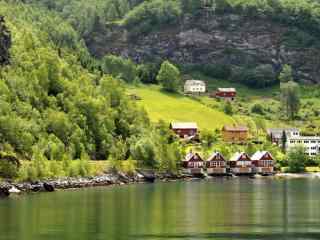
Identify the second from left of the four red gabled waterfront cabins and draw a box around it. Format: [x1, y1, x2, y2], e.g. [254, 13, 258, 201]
[206, 152, 227, 175]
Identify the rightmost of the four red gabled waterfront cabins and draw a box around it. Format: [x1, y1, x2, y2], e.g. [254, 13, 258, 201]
[251, 151, 274, 175]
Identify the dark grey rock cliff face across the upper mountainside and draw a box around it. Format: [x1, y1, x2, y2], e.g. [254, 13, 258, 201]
[87, 14, 320, 83]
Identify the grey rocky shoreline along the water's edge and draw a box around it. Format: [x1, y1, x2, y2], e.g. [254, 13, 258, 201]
[0, 172, 320, 198]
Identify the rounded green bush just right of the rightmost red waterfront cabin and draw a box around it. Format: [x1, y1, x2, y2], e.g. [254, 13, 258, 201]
[287, 146, 308, 173]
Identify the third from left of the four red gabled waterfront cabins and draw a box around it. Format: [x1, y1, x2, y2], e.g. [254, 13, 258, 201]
[229, 152, 253, 175]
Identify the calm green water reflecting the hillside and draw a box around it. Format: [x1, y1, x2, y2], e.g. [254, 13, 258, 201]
[0, 178, 320, 240]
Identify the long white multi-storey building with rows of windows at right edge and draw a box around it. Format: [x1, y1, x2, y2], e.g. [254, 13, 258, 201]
[286, 136, 320, 156]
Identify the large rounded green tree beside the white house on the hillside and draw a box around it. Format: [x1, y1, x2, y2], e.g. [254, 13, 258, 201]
[157, 61, 182, 92]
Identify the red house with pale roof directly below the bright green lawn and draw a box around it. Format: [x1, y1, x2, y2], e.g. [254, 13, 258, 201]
[170, 122, 198, 139]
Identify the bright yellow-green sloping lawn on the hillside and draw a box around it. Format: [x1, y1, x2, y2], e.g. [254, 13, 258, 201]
[128, 85, 234, 129]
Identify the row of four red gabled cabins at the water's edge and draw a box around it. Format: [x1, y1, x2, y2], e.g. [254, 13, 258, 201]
[183, 151, 274, 175]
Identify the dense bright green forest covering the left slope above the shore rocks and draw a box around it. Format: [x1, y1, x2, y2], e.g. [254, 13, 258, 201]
[0, 1, 180, 178]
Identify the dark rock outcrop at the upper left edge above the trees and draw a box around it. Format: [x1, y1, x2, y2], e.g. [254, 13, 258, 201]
[0, 16, 11, 66]
